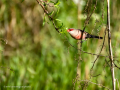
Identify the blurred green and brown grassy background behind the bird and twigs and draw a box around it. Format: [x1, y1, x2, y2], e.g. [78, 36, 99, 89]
[0, 0, 120, 90]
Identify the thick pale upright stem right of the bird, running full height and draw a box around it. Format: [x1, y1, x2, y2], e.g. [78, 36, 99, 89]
[107, 0, 115, 90]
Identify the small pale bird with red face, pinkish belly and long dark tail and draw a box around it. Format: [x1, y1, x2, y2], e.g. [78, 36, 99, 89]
[67, 28, 103, 40]
